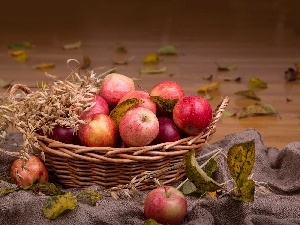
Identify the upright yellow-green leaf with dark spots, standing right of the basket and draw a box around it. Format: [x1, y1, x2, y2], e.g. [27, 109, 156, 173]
[227, 140, 255, 201]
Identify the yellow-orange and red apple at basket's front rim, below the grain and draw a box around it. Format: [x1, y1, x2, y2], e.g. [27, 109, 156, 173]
[78, 113, 119, 147]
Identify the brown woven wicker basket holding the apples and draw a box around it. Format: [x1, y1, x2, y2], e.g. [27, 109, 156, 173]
[37, 97, 229, 190]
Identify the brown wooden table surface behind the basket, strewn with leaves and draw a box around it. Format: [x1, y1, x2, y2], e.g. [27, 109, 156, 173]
[0, 0, 300, 149]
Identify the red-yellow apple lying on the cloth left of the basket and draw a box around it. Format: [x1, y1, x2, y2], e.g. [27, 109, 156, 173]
[9, 155, 48, 188]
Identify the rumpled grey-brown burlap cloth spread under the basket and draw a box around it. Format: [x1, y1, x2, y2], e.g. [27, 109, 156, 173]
[0, 129, 300, 225]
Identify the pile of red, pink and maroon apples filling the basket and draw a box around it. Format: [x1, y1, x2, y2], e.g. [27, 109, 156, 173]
[49, 73, 213, 147]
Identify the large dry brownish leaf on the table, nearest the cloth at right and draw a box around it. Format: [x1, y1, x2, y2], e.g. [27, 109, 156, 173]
[236, 103, 278, 118]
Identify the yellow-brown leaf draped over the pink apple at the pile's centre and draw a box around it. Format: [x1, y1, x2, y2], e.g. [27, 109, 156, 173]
[109, 98, 144, 126]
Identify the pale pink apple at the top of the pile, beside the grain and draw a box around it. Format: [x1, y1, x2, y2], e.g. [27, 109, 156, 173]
[99, 73, 135, 109]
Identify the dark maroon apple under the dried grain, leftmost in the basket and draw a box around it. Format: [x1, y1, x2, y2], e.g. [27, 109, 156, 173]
[48, 125, 80, 145]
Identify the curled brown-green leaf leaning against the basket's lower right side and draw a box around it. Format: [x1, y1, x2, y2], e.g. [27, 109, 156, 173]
[184, 149, 222, 192]
